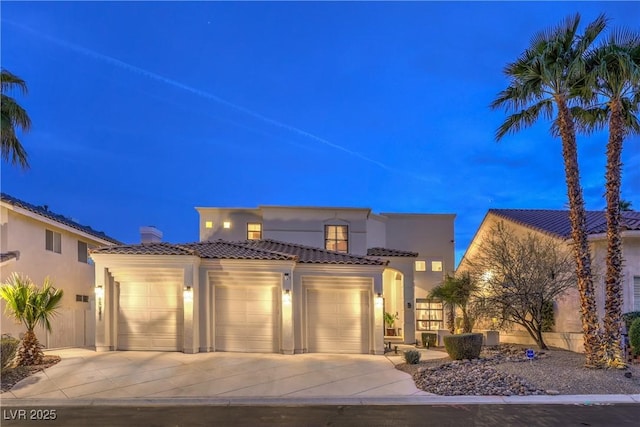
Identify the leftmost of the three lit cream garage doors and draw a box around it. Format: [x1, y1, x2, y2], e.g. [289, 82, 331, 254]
[118, 283, 183, 351]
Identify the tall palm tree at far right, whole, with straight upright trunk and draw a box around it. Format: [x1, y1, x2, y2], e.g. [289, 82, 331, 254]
[575, 31, 640, 367]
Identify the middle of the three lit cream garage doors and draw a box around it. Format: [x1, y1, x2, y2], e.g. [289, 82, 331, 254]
[214, 286, 280, 353]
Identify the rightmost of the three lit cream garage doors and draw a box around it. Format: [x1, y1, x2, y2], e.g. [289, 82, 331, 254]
[307, 289, 370, 353]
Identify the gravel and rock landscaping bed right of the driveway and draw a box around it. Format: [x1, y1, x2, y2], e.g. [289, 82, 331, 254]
[396, 344, 640, 396]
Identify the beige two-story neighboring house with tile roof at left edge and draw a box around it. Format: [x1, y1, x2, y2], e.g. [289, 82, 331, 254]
[0, 193, 120, 348]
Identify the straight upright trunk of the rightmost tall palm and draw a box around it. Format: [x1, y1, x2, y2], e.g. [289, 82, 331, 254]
[604, 99, 626, 368]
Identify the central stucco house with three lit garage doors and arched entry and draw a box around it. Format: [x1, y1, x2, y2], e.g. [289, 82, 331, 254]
[91, 206, 455, 354]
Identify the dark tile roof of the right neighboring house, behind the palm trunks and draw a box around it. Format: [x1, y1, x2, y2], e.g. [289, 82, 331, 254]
[489, 209, 640, 238]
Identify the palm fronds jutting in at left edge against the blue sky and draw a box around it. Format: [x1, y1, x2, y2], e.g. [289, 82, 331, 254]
[0, 69, 31, 169]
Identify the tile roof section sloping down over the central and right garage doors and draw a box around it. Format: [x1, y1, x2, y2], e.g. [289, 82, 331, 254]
[238, 239, 387, 265]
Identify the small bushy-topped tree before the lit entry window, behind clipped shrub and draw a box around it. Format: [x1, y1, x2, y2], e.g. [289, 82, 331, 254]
[429, 272, 478, 333]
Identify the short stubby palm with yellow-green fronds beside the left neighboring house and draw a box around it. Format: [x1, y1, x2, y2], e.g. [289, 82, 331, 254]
[0, 273, 63, 366]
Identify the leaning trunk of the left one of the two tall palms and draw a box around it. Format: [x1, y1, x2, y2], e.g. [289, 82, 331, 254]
[556, 95, 604, 368]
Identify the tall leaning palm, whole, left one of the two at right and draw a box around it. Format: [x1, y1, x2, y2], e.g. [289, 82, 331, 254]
[491, 14, 606, 367]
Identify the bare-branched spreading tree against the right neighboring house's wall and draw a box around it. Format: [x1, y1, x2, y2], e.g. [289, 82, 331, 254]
[470, 222, 576, 349]
